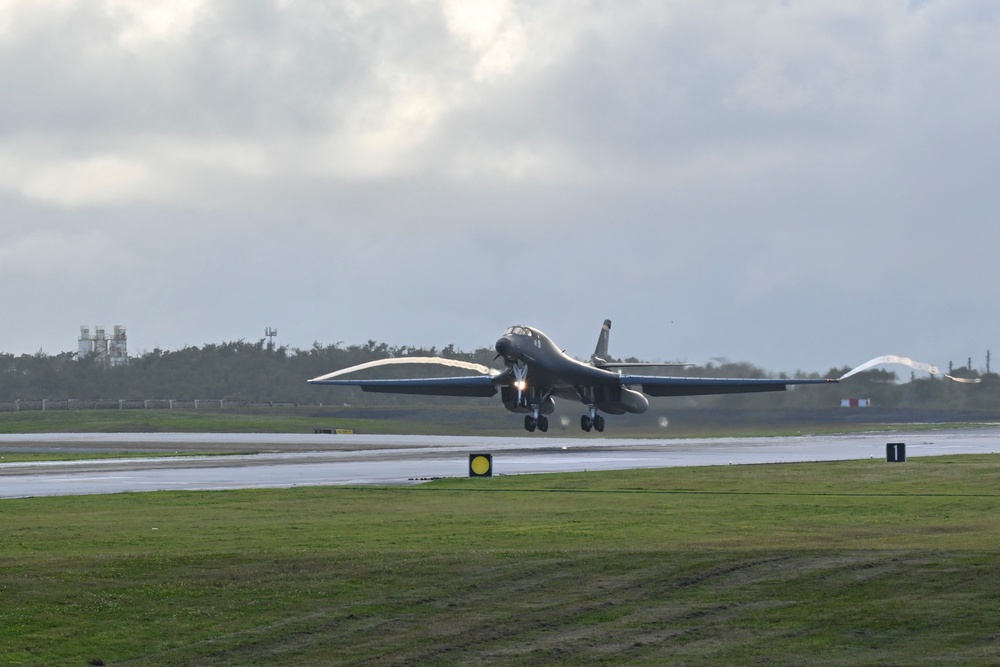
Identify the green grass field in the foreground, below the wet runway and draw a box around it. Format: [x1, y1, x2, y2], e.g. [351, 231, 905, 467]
[0, 456, 1000, 667]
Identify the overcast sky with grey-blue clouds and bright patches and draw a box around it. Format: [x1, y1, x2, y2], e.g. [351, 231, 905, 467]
[0, 0, 1000, 374]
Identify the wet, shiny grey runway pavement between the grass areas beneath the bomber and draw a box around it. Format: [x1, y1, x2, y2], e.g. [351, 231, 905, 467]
[0, 425, 1000, 498]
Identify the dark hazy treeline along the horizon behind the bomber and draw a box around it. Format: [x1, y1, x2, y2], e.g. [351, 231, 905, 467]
[0, 339, 1000, 410]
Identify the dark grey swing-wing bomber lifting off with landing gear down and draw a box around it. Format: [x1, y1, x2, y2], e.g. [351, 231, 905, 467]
[309, 320, 837, 432]
